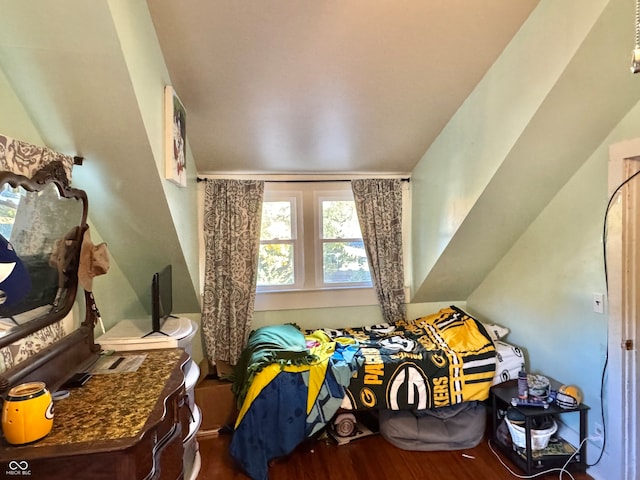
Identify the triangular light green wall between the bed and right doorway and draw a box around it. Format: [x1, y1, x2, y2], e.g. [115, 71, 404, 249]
[467, 96, 640, 478]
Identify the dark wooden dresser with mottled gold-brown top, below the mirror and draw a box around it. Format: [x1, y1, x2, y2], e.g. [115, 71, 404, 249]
[0, 348, 191, 480]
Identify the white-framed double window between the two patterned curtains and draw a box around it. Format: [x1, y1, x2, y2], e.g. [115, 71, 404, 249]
[198, 176, 411, 315]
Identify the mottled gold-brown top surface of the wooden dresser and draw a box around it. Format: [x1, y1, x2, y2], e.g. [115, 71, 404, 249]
[2, 349, 184, 449]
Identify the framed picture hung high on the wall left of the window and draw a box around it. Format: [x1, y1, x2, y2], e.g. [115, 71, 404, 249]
[164, 85, 187, 187]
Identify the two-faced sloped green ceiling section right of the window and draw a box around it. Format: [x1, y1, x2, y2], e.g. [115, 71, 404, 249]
[412, 0, 640, 301]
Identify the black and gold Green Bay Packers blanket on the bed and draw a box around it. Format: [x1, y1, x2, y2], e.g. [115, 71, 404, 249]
[338, 306, 495, 410]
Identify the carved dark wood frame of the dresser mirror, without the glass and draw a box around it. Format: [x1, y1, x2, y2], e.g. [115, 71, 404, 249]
[0, 161, 100, 392]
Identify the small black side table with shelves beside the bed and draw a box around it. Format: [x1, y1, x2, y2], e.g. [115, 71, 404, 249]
[490, 378, 589, 475]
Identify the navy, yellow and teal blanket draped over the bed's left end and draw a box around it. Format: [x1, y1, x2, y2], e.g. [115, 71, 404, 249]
[229, 325, 358, 480]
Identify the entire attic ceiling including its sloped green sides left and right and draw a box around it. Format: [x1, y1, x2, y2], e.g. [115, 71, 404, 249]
[0, 0, 640, 312]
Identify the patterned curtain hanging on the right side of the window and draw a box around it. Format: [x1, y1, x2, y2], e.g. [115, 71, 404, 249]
[351, 179, 406, 322]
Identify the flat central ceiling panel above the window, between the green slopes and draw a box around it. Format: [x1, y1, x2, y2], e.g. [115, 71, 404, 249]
[147, 0, 538, 174]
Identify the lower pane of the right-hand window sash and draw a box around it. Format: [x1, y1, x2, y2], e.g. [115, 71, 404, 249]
[322, 242, 371, 283]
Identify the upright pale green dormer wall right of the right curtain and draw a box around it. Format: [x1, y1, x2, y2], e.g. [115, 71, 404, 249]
[411, 0, 608, 301]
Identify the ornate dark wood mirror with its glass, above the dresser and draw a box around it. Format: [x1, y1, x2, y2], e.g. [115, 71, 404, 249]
[0, 161, 95, 391]
